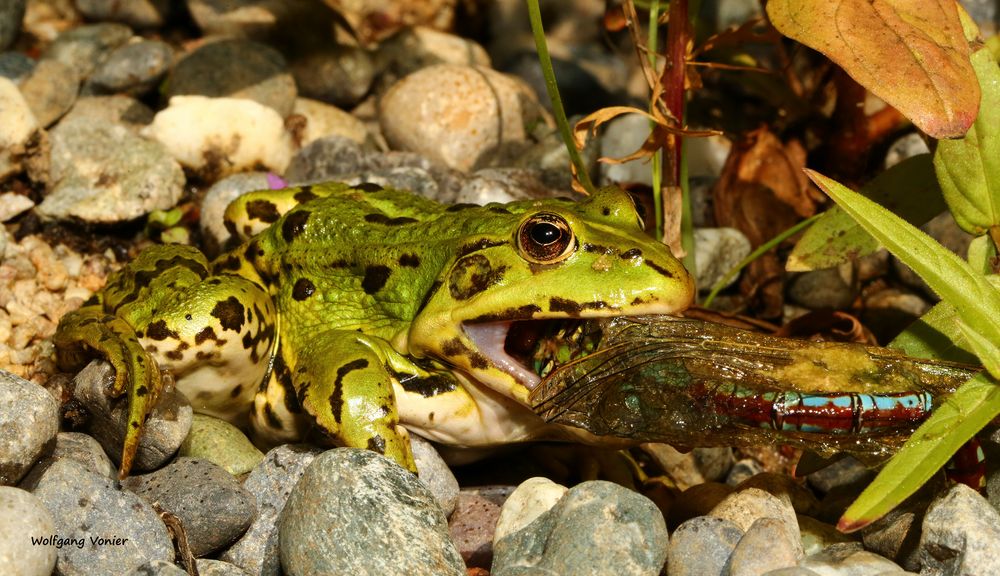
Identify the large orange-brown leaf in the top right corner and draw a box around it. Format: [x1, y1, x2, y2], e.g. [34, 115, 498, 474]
[767, 0, 979, 138]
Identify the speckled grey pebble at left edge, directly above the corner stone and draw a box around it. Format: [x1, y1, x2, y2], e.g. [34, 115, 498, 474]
[0, 370, 59, 486]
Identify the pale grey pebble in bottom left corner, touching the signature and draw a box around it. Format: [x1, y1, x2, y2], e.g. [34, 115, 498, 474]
[0, 486, 56, 576]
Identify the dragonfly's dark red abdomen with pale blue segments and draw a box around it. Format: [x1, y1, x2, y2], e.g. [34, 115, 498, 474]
[691, 383, 932, 434]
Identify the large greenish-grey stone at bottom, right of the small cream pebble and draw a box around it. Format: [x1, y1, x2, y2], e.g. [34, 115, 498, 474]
[491, 480, 668, 576]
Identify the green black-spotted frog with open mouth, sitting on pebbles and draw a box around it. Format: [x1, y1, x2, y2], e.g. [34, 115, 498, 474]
[54, 184, 694, 476]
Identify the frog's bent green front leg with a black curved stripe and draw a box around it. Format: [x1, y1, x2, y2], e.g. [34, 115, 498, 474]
[284, 330, 417, 472]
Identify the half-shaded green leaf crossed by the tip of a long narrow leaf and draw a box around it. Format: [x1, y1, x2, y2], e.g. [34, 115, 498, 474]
[785, 154, 947, 272]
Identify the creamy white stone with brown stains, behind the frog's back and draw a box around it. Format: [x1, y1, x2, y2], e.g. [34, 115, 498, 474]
[141, 96, 293, 180]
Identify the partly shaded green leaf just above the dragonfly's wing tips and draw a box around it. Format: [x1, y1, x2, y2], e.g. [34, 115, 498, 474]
[889, 301, 979, 364]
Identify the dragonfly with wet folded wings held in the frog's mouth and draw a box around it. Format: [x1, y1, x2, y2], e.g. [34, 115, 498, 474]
[529, 316, 981, 464]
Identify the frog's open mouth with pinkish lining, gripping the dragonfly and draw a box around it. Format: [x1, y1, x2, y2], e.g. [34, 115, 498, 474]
[463, 320, 602, 390]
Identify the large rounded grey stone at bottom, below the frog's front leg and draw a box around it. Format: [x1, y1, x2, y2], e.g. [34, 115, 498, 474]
[279, 448, 465, 576]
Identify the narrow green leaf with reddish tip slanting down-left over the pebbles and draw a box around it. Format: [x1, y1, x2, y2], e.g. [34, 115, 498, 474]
[837, 372, 1000, 532]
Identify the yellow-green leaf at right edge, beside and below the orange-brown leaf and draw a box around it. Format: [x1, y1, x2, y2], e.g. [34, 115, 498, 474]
[934, 48, 1000, 236]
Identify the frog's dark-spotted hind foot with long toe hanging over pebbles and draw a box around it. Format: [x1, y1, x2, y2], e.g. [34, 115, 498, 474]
[53, 306, 163, 478]
